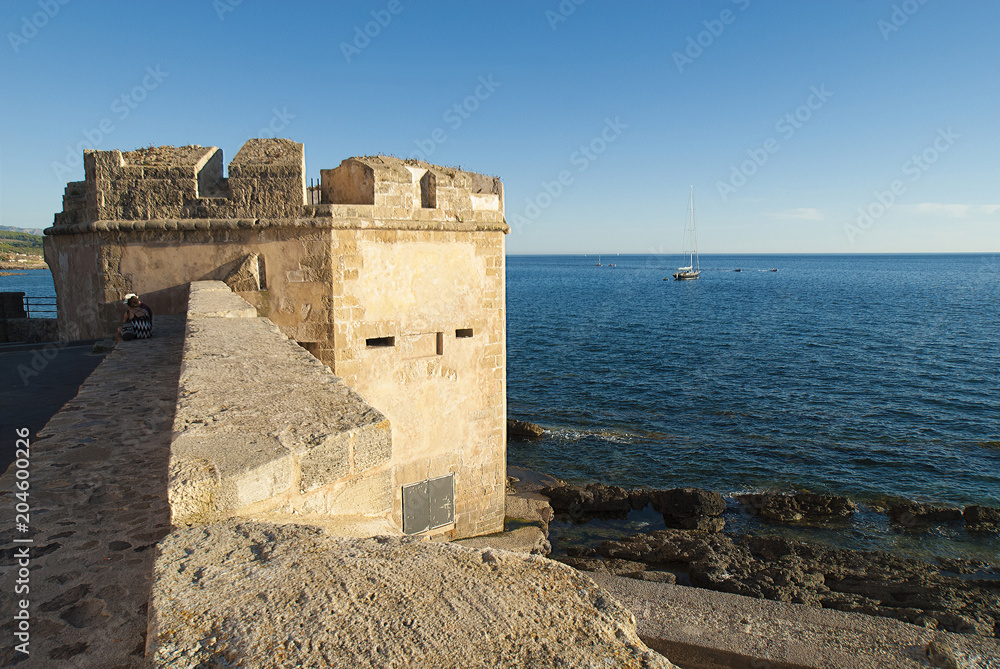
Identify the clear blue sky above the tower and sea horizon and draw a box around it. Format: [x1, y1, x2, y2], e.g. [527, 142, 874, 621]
[0, 0, 1000, 253]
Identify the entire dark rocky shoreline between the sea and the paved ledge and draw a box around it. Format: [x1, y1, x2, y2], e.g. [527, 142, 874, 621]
[511, 467, 1000, 638]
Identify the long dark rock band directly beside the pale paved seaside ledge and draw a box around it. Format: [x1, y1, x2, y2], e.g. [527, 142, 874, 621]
[598, 529, 1000, 638]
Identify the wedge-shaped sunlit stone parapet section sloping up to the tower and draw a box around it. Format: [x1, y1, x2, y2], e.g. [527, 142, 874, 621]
[169, 281, 392, 531]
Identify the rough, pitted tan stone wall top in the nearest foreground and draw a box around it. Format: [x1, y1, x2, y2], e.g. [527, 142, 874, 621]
[149, 521, 674, 669]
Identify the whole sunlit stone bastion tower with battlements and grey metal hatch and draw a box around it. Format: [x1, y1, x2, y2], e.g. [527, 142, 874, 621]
[45, 139, 509, 538]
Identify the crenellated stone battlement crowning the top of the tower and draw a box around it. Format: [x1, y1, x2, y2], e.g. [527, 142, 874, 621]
[49, 139, 505, 234]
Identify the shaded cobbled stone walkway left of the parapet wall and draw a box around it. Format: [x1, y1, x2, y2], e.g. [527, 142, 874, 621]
[0, 316, 184, 669]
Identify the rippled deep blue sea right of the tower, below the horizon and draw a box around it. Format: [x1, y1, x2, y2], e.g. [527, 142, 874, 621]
[507, 254, 1000, 560]
